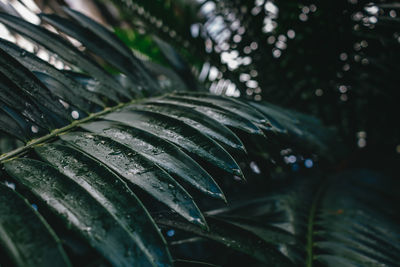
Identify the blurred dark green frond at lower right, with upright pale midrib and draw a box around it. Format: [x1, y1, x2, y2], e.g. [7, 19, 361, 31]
[159, 170, 400, 266]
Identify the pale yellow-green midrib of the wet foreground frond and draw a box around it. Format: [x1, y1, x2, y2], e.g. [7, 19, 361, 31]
[0, 99, 143, 163]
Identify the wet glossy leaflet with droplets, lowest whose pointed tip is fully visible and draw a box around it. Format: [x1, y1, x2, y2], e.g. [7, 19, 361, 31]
[60, 132, 206, 227]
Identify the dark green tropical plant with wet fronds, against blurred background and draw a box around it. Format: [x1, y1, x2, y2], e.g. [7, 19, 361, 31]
[0, 2, 400, 266]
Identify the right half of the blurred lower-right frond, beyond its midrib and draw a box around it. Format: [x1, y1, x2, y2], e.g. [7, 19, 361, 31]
[309, 170, 400, 266]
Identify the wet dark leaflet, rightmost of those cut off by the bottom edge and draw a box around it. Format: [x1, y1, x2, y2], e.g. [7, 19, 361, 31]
[35, 144, 172, 266]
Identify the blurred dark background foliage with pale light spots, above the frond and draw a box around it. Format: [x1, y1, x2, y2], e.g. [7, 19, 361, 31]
[113, 0, 400, 153]
